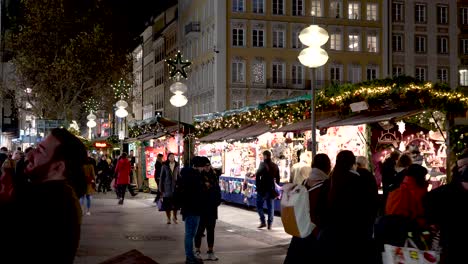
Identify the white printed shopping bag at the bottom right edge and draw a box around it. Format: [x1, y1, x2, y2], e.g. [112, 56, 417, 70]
[382, 238, 440, 264]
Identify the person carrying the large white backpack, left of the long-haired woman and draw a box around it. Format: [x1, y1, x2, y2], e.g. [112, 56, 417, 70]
[284, 153, 331, 264]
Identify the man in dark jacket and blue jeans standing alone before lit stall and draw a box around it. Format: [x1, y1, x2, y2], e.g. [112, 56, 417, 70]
[256, 150, 280, 229]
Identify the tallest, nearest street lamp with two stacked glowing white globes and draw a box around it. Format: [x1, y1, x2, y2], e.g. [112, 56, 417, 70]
[298, 25, 329, 157]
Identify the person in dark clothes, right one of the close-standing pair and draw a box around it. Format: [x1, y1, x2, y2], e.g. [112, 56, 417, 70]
[195, 157, 221, 261]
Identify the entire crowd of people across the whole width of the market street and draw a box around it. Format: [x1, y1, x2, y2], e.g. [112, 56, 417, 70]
[0, 129, 468, 264]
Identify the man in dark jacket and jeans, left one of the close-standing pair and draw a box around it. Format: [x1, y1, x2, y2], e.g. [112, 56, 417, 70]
[180, 156, 207, 264]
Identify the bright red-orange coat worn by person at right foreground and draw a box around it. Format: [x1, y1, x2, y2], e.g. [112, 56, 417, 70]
[385, 176, 427, 227]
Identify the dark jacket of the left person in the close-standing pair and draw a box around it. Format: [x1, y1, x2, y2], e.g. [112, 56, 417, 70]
[177, 167, 204, 217]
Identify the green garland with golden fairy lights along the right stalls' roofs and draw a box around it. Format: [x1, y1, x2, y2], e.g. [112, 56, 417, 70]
[195, 76, 468, 137]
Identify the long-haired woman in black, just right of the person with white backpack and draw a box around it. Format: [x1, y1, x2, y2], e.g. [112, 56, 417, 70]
[319, 150, 377, 263]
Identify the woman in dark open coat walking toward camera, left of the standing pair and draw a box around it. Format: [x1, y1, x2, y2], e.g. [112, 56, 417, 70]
[159, 153, 180, 224]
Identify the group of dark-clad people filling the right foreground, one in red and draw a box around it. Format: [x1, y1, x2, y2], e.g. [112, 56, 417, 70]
[282, 150, 468, 264]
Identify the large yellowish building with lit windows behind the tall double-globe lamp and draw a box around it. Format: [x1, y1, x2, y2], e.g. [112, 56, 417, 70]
[179, 0, 388, 116]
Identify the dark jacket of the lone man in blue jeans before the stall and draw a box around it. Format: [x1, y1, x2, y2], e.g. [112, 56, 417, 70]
[255, 159, 280, 198]
